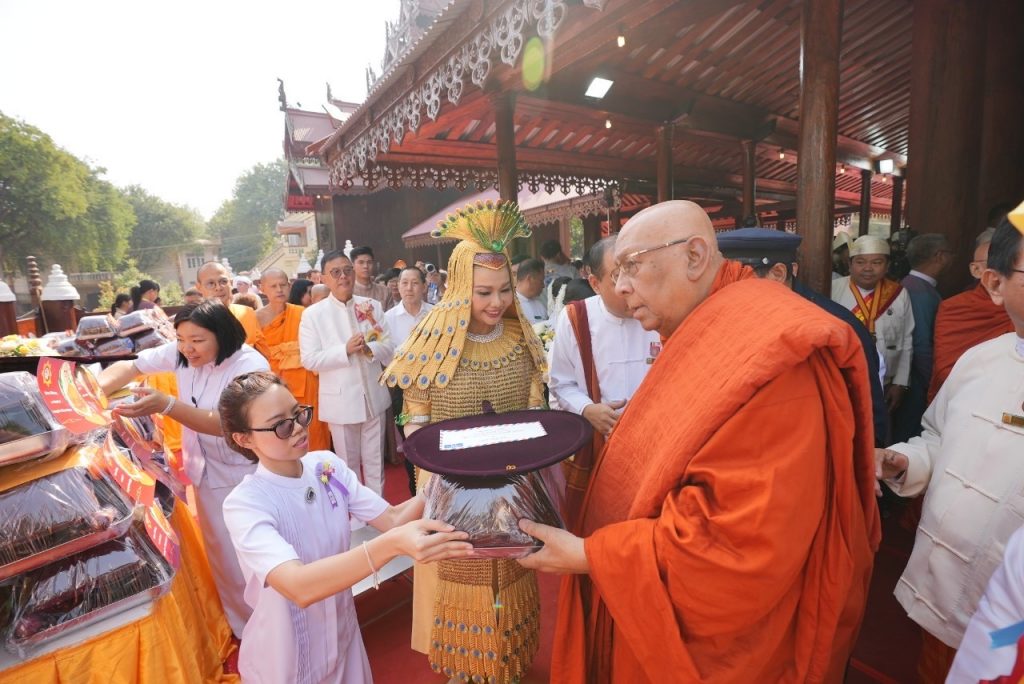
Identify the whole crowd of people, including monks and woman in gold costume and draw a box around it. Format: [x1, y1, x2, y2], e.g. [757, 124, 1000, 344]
[92, 196, 1024, 683]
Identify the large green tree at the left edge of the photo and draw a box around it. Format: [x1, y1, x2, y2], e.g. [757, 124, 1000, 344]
[0, 113, 135, 272]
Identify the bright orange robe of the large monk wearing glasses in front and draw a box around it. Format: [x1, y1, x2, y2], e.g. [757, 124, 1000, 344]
[551, 262, 881, 684]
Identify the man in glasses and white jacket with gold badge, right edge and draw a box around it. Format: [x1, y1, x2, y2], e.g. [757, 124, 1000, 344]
[876, 215, 1024, 681]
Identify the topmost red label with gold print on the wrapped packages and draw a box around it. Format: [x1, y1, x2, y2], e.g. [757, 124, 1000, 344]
[36, 356, 111, 434]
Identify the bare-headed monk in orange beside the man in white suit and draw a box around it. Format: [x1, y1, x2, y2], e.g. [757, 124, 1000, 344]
[250, 268, 331, 452]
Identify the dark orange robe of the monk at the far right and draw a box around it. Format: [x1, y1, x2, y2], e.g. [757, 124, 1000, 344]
[928, 283, 1014, 403]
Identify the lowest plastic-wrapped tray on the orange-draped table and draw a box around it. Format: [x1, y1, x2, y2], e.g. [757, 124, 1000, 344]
[5, 525, 173, 657]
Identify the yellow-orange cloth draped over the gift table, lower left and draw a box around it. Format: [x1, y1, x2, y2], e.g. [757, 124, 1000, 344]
[0, 502, 240, 684]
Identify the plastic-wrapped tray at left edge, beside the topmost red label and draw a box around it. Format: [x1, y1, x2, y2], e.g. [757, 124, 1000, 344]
[0, 371, 70, 466]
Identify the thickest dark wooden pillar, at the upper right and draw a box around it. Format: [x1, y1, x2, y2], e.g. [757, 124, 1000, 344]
[906, 0, 987, 294]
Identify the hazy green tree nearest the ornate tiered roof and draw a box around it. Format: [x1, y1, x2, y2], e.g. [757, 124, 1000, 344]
[209, 159, 288, 271]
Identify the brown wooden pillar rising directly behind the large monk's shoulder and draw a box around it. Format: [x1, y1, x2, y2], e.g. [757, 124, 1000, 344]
[797, 0, 843, 295]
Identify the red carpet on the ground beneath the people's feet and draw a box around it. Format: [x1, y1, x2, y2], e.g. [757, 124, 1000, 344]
[364, 466, 921, 684]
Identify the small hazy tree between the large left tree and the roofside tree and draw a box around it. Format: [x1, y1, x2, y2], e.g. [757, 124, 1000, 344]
[123, 185, 206, 270]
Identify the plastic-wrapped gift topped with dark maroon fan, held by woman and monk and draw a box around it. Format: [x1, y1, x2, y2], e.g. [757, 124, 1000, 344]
[403, 411, 591, 558]
